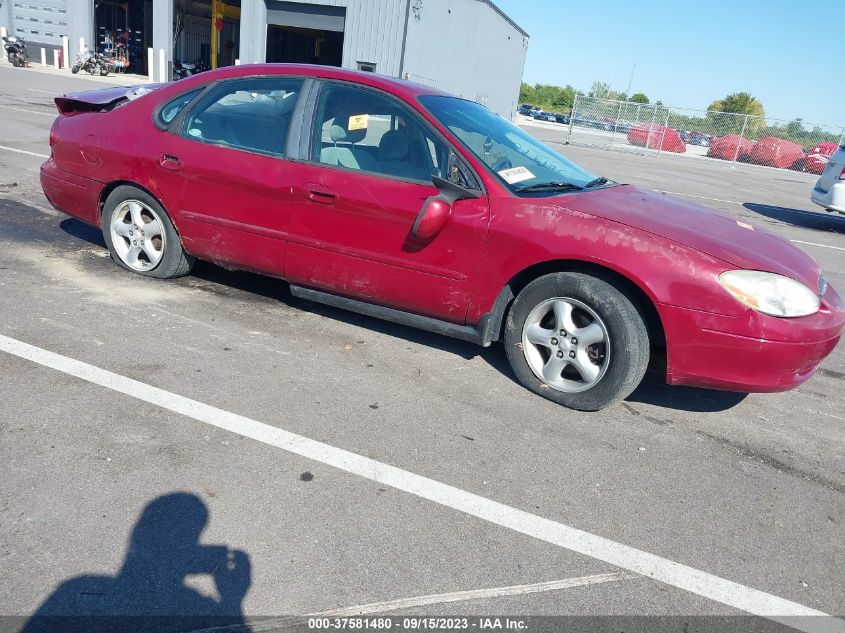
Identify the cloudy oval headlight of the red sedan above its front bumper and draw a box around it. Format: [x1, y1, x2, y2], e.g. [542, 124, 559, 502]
[719, 270, 821, 317]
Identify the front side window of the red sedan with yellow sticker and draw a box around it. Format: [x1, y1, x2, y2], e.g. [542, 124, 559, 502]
[311, 84, 449, 182]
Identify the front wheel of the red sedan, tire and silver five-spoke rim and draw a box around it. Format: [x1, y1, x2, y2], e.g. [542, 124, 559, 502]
[505, 272, 650, 411]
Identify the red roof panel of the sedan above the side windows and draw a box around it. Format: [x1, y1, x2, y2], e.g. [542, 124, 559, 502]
[185, 64, 456, 100]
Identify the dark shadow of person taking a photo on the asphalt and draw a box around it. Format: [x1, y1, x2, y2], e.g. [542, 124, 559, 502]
[21, 492, 251, 633]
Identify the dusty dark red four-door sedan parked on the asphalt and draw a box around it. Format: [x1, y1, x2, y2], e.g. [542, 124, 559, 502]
[41, 65, 845, 410]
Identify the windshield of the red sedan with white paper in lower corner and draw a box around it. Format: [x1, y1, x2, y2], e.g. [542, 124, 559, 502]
[419, 95, 596, 194]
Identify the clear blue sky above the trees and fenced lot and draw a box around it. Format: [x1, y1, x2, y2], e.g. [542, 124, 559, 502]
[494, 0, 845, 128]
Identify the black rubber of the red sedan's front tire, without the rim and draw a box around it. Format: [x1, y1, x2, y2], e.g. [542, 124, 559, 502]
[504, 272, 650, 411]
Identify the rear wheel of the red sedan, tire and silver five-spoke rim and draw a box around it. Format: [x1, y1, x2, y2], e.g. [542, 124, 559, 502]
[100, 186, 194, 279]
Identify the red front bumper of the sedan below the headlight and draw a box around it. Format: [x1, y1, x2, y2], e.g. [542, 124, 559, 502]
[658, 288, 845, 392]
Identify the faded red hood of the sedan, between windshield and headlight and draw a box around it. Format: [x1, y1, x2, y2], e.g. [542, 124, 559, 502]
[559, 185, 821, 290]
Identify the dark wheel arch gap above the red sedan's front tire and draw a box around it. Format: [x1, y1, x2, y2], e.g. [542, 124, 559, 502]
[482, 259, 666, 369]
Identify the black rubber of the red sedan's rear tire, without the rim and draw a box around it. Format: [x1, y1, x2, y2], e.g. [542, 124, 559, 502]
[100, 185, 196, 279]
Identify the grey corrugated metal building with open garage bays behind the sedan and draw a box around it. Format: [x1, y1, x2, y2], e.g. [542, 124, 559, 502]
[0, 0, 528, 118]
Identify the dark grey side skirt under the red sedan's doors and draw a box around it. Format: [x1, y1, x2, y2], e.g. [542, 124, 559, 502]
[290, 284, 492, 347]
